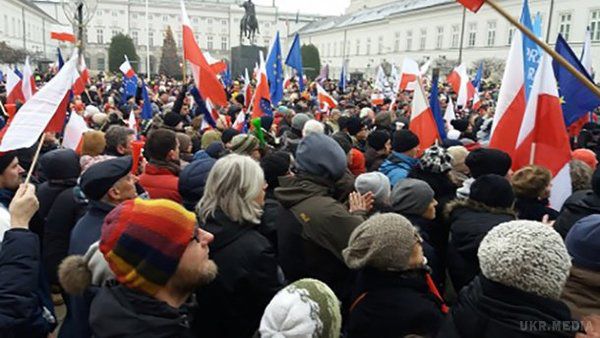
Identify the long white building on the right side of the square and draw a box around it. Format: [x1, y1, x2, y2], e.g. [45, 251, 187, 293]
[300, 0, 600, 77]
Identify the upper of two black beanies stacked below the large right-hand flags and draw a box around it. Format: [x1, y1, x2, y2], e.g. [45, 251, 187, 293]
[465, 148, 512, 178]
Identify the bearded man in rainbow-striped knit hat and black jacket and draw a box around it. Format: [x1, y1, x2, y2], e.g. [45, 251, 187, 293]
[90, 198, 217, 338]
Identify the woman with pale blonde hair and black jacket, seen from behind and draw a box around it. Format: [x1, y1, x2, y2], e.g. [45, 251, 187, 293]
[194, 154, 283, 338]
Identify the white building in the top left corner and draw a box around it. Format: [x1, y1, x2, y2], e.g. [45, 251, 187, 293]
[0, 0, 57, 60]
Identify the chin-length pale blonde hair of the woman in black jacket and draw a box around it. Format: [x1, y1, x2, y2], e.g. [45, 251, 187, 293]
[196, 154, 265, 224]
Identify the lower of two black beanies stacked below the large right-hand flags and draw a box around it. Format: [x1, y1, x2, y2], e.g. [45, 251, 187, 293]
[469, 174, 515, 208]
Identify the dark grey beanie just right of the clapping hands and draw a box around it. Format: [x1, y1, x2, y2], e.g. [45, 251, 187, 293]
[391, 178, 435, 216]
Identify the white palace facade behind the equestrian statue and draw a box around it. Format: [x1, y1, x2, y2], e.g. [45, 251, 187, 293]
[35, 0, 323, 73]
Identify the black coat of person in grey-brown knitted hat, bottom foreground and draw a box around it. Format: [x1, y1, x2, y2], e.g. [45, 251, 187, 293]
[347, 268, 445, 338]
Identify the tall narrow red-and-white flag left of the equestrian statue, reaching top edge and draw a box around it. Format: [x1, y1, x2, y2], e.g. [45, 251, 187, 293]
[181, 0, 227, 106]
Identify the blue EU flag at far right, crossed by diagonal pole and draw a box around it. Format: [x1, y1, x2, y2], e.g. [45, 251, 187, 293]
[552, 34, 600, 127]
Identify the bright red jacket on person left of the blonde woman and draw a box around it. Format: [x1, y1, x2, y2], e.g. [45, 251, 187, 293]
[139, 163, 183, 203]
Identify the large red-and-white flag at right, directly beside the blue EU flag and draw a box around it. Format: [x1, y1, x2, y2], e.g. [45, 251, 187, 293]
[513, 53, 571, 210]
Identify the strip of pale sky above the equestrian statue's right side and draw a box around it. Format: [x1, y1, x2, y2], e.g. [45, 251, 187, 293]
[253, 0, 350, 15]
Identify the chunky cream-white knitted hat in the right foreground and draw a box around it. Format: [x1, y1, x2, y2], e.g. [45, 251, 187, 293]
[477, 220, 571, 299]
